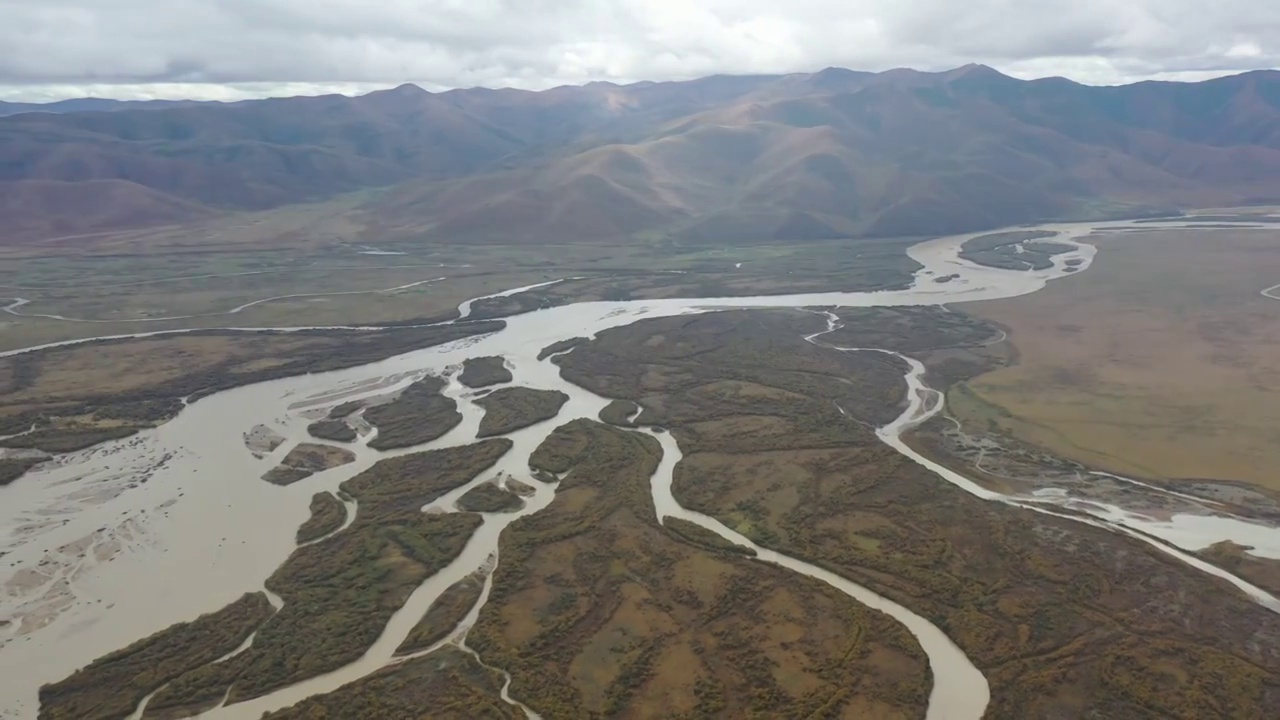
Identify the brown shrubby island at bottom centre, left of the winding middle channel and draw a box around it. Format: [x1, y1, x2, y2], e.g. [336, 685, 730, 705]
[467, 420, 928, 719]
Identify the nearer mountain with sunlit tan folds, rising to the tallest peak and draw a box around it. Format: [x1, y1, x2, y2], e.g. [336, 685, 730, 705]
[374, 68, 1280, 242]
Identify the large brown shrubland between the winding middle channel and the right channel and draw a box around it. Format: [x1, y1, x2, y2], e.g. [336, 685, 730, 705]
[559, 310, 1280, 719]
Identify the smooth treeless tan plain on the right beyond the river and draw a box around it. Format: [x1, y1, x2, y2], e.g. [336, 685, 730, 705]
[948, 229, 1280, 491]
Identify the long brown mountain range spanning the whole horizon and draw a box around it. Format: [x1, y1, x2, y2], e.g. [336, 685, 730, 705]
[0, 65, 1280, 243]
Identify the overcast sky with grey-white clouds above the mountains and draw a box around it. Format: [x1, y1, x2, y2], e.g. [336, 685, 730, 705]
[0, 0, 1280, 101]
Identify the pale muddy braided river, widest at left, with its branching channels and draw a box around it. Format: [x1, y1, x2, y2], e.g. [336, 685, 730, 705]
[0, 217, 1269, 717]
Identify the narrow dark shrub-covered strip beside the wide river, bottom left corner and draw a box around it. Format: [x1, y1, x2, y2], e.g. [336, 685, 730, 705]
[40, 593, 273, 720]
